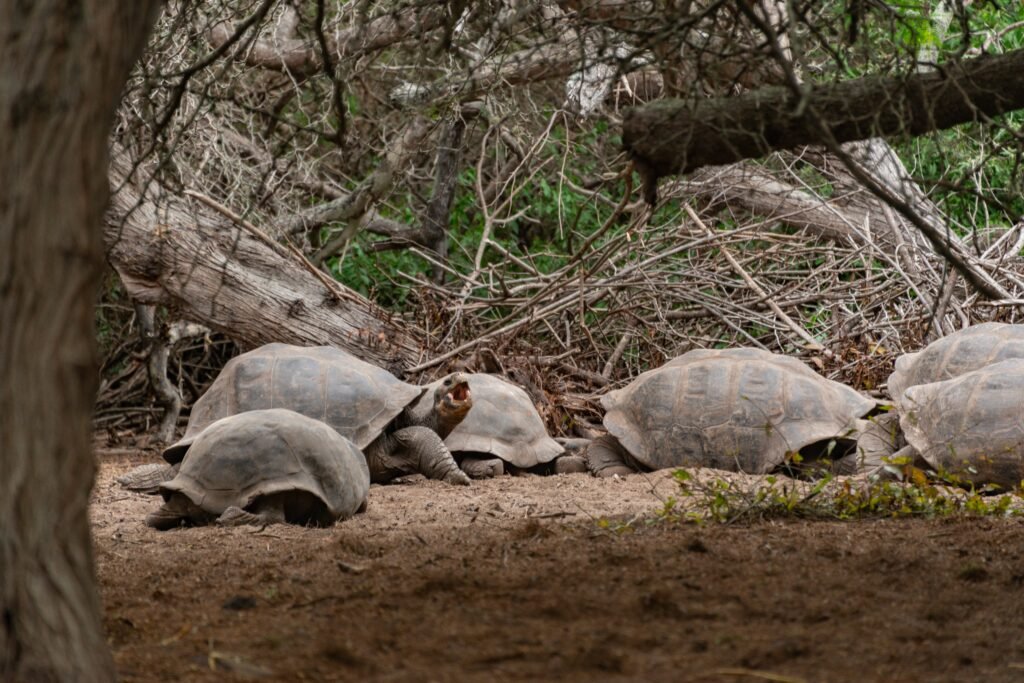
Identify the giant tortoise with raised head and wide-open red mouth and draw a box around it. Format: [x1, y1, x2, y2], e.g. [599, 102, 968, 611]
[121, 344, 473, 492]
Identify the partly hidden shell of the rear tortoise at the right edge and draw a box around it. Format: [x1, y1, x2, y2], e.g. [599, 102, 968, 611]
[889, 323, 1024, 405]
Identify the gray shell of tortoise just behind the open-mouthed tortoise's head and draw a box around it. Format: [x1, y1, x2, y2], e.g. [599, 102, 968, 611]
[420, 373, 565, 469]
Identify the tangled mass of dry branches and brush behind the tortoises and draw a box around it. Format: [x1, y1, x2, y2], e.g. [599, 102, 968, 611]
[97, 0, 1024, 434]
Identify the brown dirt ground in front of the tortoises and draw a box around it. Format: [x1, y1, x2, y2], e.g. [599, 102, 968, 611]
[92, 450, 1024, 682]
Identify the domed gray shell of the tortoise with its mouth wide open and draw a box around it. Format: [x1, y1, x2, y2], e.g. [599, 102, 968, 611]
[164, 344, 423, 464]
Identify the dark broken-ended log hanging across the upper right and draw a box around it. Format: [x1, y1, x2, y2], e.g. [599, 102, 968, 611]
[623, 50, 1024, 179]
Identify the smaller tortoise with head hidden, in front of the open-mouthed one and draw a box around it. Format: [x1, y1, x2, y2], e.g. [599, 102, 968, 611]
[145, 409, 370, 529]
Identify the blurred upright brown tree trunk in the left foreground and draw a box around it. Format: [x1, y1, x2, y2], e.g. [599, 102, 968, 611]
[0, 0, 160, 682]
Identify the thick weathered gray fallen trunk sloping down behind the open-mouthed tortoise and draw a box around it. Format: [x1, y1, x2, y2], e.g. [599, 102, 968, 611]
[103, 150, 423, 367]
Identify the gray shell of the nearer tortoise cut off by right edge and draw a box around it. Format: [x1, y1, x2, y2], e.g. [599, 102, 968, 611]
[900, 358, 1024, 488]
